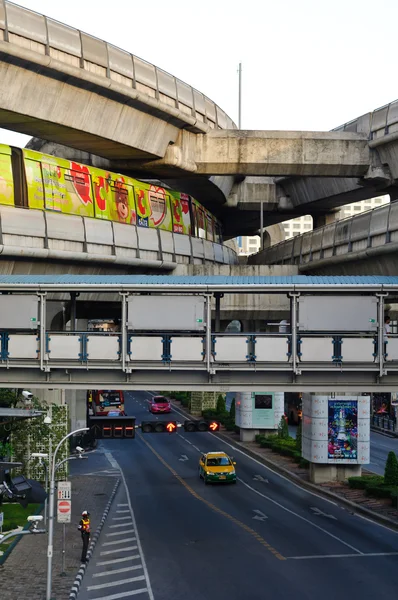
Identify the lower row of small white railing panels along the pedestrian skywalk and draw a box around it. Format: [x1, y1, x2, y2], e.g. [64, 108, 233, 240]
[0, 331, 398, 373]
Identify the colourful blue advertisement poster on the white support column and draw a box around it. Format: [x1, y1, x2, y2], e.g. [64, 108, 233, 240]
[328, 400, 358, 460]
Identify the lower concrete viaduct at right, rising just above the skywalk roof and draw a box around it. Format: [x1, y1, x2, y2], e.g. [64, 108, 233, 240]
[248, 202, 398, 276]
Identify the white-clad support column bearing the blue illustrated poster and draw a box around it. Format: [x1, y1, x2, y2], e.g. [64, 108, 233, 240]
[302, 393, 370, 483]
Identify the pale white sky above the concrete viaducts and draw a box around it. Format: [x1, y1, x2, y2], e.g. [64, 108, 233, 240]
[0, 0, 398, 145]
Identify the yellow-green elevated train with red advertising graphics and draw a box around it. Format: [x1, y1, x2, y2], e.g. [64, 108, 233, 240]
[0, 144, 222, 244]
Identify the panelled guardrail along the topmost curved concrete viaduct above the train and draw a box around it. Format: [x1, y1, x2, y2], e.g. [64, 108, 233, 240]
[0, 0, 236, 132]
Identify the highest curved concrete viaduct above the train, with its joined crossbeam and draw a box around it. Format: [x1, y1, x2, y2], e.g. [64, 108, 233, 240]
[0, 0, 385, 237]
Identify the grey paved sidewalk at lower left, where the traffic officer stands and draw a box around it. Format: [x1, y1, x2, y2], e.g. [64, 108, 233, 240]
[0, 473, 116, 600]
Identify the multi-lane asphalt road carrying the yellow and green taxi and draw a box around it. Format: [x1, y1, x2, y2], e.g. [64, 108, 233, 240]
[79, 392, 398, 600]
